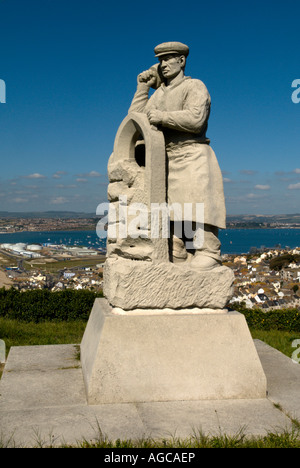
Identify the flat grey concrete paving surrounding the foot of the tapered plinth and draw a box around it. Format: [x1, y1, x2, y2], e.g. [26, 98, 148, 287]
[0, 340, 300, 447]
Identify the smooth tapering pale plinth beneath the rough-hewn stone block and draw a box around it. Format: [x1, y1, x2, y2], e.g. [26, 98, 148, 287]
[81, 299, 266, 405]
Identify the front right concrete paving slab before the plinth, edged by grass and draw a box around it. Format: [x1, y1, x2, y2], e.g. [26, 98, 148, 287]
[136, 399, 290, 438]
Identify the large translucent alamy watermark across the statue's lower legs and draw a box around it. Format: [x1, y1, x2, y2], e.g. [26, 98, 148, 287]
[96, 195, 204, 249]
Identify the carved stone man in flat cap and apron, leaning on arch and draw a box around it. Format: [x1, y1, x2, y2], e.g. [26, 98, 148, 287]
[129, 42, 226, 270]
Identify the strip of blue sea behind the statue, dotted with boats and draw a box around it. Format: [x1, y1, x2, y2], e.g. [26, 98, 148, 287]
[0, 229, 300, 254]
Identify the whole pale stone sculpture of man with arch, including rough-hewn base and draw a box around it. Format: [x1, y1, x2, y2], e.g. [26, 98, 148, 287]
[104, 42, 233, 310]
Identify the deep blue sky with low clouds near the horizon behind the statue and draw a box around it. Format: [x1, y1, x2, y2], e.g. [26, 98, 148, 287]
[0, 0, 300, 214]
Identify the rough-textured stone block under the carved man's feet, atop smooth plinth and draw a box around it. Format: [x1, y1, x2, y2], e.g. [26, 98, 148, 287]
[104, 258, 234, 310]
